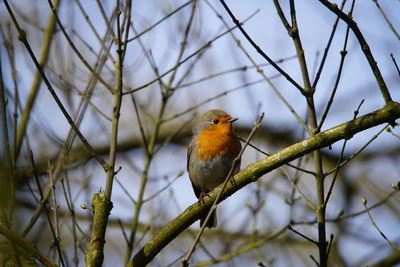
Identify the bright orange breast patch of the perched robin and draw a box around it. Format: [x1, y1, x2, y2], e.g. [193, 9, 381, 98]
[196, 125, 241, 160]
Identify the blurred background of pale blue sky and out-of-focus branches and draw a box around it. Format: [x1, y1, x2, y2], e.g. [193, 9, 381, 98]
[0, 0, 400, 266]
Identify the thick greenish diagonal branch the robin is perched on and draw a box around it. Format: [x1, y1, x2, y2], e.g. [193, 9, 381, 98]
[128, 102, 400, 266]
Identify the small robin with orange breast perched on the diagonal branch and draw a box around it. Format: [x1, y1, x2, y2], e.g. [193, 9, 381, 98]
[187, 109, 242, 228]
